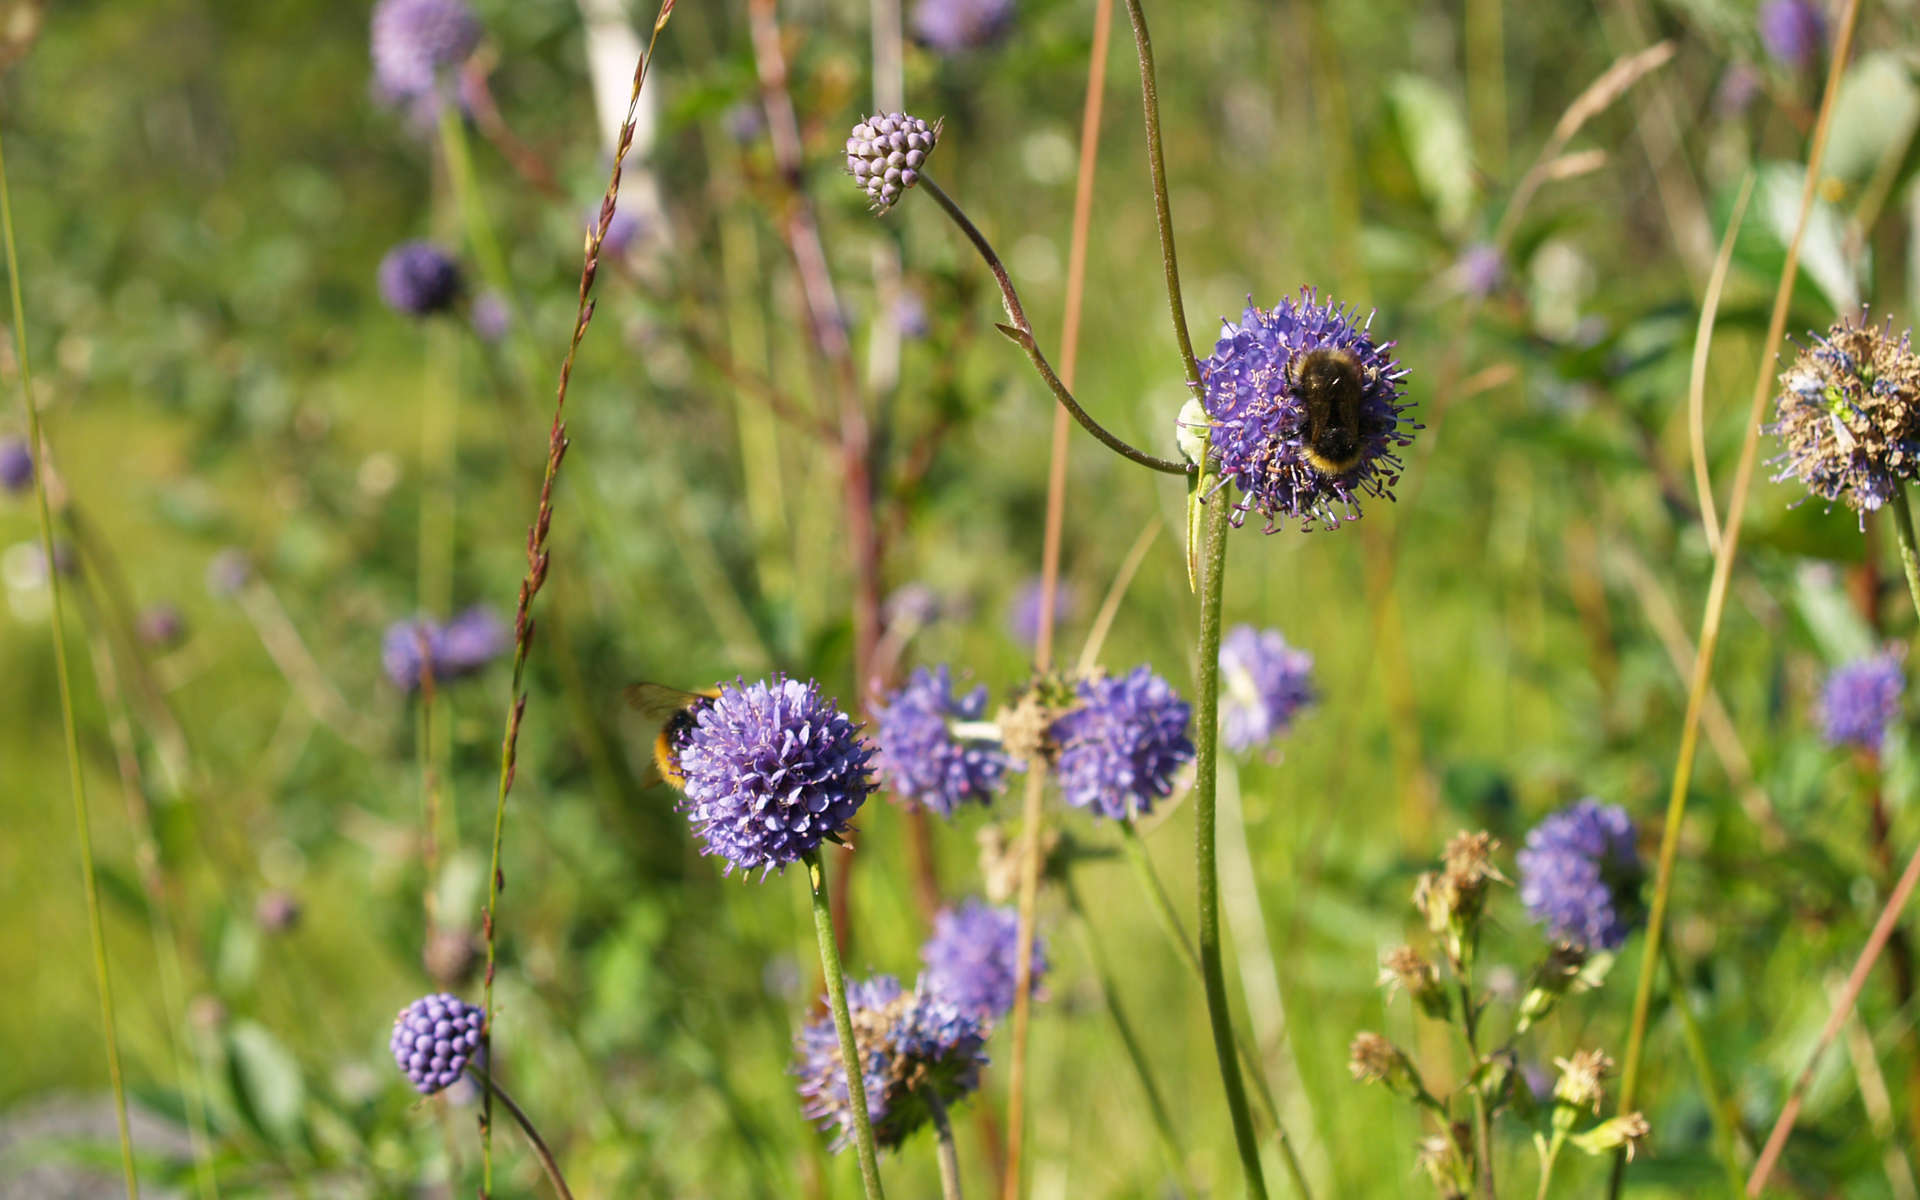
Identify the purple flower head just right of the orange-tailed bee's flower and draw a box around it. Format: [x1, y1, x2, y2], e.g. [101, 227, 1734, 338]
[874, 662, 1010, 816]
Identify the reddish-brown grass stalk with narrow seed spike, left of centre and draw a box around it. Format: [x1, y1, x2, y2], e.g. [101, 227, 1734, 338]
[480, 11, 674, 1196]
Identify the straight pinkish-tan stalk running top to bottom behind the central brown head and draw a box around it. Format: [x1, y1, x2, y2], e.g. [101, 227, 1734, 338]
[1000, 0, 1114, 1200]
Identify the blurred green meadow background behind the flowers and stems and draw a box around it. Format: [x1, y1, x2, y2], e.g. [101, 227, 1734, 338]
[0, 0, 1920, 1196]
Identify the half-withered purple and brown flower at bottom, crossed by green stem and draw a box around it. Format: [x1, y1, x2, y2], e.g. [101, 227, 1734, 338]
[795, 975, 987, 1152]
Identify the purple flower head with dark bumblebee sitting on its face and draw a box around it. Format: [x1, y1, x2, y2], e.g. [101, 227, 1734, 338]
[1200, 290, 1421, 534]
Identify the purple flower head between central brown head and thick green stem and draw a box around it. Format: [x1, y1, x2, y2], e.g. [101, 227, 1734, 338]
[1052, 666, 1194, 820]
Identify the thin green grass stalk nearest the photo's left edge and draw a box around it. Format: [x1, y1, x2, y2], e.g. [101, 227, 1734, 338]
[0, 121, 140, 1198]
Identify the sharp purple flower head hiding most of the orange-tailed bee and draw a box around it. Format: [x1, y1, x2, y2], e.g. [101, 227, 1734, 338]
[676, 674, 874, 879]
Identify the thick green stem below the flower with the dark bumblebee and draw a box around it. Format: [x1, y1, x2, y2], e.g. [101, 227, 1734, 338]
[1190, 491, 1267, 1200]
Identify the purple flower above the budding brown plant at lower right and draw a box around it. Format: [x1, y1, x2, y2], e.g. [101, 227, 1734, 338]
[1519, 799, 1642, 950]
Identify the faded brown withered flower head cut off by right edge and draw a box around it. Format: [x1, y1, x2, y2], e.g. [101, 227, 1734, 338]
[1766, 311, 1920, 528]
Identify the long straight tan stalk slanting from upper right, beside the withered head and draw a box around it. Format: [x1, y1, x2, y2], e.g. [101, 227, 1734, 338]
[1609, 0, 1858, 1198]
